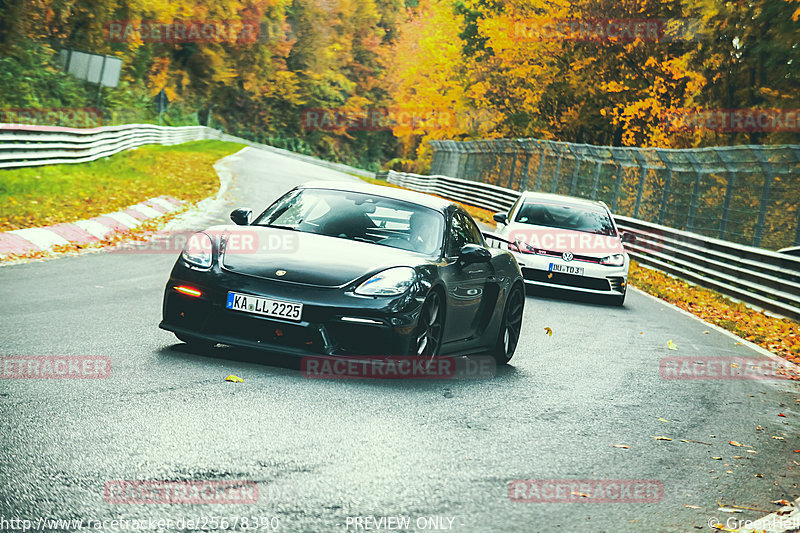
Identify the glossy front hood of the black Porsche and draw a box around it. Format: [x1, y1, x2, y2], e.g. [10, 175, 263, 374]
[214, 226, 431, 287]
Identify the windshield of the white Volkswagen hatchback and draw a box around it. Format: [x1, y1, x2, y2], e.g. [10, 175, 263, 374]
[514, 201, 617, 236]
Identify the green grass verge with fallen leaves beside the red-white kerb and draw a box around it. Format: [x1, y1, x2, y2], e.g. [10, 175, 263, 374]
[0, 141, 244, 231]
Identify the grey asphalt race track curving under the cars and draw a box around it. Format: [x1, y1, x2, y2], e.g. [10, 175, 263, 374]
[0, 145, 800, 532]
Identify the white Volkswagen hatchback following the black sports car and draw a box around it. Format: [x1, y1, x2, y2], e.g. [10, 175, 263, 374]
[494, 192, 633, 305]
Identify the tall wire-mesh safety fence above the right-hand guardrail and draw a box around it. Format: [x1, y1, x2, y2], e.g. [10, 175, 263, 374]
[430, 139, 800, 249]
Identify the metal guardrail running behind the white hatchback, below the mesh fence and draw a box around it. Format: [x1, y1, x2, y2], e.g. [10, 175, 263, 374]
[387, 171, 800, 320]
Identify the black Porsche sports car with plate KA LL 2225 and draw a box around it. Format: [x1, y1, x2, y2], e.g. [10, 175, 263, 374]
[160, 182, 525, 364]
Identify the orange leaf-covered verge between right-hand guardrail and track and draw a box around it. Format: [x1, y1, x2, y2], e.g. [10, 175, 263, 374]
[361, 178, 800, 364]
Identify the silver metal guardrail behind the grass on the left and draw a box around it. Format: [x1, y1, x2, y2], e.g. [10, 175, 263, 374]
[0, 124, 214, 168]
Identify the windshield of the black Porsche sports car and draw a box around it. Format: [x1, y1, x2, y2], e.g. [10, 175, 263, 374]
[253, 189, 444, 255]
